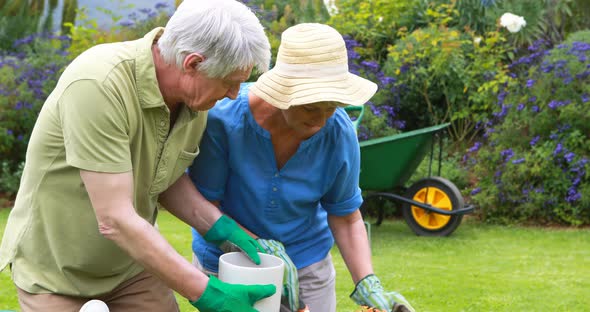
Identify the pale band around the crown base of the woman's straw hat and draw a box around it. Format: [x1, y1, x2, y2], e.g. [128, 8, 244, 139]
[272, 62, 348, 78]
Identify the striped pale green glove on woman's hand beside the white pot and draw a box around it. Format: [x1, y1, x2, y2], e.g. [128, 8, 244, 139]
[258, 238, 305, 311]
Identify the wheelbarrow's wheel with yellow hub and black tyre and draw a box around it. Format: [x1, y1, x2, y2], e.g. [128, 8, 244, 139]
[402, 177, 464, 236]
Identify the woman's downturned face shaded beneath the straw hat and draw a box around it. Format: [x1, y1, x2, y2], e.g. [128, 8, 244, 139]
[282, 102, 340, 139]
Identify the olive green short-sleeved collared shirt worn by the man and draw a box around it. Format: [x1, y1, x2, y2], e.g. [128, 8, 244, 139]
[0, 28, 207, 297]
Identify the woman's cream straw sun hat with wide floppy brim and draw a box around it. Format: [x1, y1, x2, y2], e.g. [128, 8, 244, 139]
[250, 23, 377, 109]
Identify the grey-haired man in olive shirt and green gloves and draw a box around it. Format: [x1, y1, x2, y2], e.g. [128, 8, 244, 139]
[0, 0, 275, 312]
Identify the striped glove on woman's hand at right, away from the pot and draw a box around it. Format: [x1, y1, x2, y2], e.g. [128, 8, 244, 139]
[350, 274, 415, 312]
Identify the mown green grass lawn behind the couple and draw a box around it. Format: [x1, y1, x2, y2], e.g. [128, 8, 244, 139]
[0, 209, 590, 312]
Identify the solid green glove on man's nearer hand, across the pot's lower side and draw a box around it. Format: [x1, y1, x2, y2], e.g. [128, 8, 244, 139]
[189, 275, 276, 312]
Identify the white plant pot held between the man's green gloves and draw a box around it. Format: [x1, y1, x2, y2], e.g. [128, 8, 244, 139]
[219, 252, 285, 312]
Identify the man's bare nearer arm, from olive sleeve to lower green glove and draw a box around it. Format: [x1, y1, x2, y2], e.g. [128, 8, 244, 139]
[80, 170, 208, 300]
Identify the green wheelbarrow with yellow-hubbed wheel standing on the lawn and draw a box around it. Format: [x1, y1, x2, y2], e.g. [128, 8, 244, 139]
[346, 106, 475, 238]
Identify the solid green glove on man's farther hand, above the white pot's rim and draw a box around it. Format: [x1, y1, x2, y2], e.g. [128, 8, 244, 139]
[203, 215, 263, 264]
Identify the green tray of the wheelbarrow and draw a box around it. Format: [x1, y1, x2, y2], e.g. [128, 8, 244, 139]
[359, 123, 449, 191]
